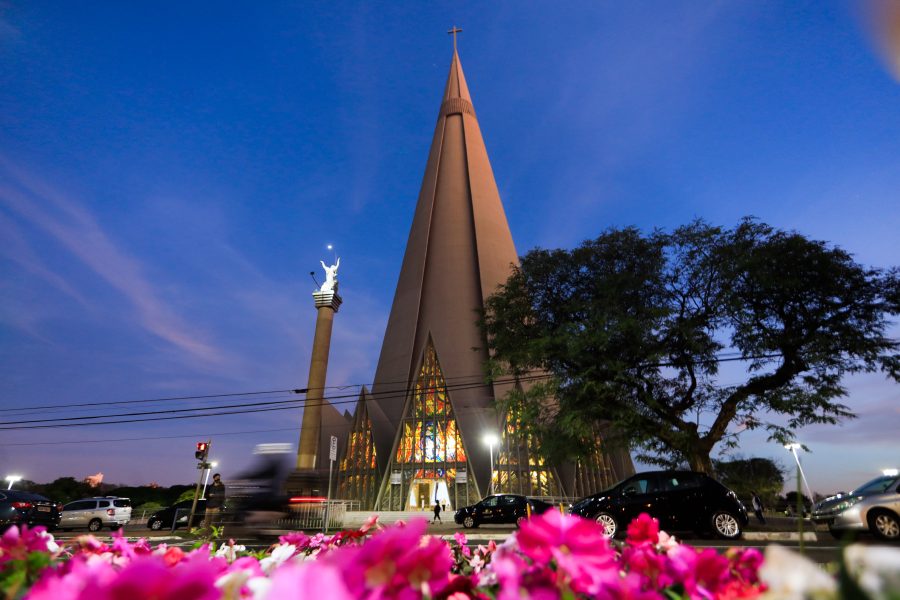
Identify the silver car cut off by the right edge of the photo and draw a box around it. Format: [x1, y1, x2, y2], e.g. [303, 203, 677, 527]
[812, 475, 900, 541]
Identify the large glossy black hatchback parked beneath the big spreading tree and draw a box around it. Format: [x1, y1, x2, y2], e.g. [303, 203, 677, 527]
[571, 471, 748, 540]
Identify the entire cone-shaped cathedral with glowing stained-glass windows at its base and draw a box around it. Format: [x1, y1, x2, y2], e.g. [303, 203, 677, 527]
[306, 48, 634, 510]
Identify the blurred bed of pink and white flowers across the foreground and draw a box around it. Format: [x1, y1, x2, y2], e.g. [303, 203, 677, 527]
[0, 511, 900, 600]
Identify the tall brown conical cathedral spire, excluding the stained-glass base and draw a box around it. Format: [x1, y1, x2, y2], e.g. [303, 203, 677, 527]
[370, 45, 518, 491]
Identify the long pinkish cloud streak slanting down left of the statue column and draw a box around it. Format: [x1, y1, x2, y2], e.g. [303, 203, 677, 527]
[0, 157, 226, 364]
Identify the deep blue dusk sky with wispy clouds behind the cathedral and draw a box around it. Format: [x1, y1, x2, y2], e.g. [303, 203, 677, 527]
[0, 0, 900, 493]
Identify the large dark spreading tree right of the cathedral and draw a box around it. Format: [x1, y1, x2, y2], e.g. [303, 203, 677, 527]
[481, 219, 900, 473]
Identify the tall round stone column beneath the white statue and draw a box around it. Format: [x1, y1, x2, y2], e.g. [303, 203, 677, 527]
[297, 291, 342, 469]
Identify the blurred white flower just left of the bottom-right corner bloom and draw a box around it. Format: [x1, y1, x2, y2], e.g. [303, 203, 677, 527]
[759, 544, 837, 600]
